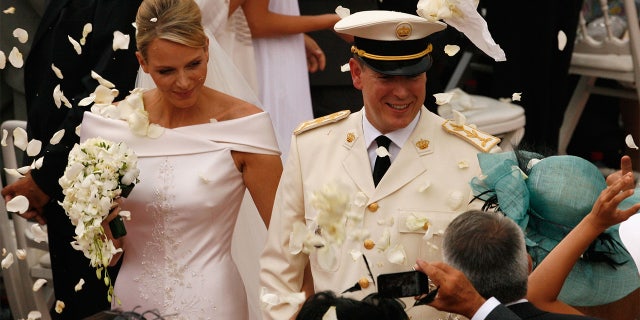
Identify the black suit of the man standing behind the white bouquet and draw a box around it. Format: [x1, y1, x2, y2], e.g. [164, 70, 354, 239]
[25, 0, 141, 320]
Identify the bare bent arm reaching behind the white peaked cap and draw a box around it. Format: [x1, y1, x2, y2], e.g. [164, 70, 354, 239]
[242, 0, 340, 38]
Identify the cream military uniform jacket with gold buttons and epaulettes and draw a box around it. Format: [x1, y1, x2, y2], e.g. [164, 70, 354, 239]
[260, 107, 499, 320]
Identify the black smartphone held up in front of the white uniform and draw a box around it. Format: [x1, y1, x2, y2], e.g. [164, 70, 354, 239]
[378, 271, 429, 298]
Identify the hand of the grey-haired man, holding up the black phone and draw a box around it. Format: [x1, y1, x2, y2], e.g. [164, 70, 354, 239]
[415, 259, 486, 319]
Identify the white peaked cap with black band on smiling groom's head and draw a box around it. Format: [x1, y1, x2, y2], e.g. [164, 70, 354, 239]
[334, 10, 447, 76]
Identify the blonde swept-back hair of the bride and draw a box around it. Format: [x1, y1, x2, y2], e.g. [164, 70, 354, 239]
[136, 0, 207, 60]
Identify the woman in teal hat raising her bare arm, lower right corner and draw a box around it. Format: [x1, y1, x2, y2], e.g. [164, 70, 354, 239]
[471, 151, 640, 320]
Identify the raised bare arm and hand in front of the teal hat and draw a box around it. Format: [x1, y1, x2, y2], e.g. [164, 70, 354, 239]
[527, 173, 640, 314]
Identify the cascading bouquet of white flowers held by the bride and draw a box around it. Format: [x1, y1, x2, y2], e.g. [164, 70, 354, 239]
[58, 138, 140, 301]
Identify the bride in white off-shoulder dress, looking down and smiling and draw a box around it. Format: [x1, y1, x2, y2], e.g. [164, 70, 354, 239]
[81, 0, 282, 319]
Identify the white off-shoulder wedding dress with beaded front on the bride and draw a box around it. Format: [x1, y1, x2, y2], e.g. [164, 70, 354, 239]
[81, 108, 278, 319]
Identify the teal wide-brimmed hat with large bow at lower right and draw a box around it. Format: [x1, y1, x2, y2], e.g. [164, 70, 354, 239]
[471, 151, 640, 306]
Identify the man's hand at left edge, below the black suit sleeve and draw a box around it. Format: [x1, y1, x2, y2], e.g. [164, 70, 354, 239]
[2, 172, 50, 225]
